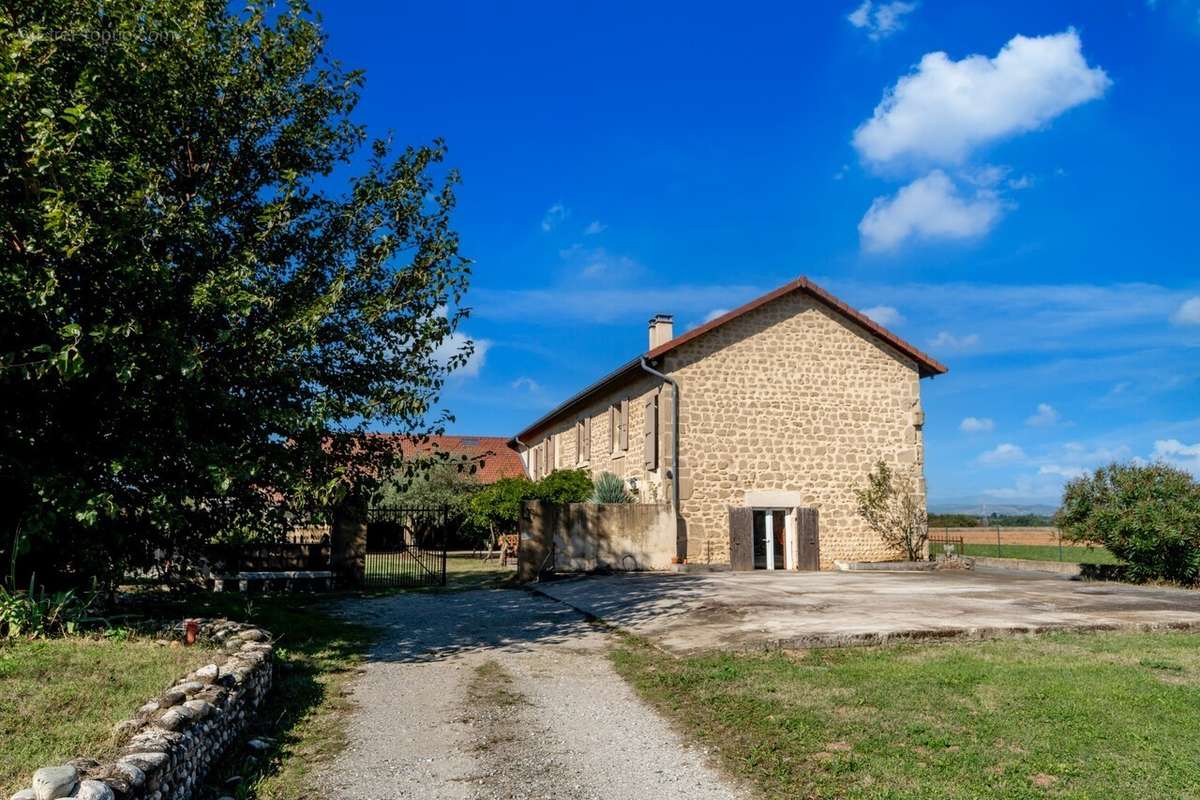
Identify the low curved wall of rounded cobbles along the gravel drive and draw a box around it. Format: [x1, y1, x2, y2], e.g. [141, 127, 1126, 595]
[12, 620, 274, 800]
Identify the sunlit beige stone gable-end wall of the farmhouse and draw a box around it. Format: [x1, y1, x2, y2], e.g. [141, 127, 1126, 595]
[662, 293, 925, 569]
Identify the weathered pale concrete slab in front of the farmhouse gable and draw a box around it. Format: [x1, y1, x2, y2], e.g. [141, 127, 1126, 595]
[535, 571, 1200, 654]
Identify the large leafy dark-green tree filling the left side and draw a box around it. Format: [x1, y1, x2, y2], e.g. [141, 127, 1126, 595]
[0, 0, 470, 587]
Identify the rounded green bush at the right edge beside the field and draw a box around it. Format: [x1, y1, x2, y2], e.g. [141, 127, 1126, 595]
[1055, 464, 1200, 584]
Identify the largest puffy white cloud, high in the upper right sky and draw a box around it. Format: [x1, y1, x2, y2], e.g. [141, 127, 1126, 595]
[853, 29, 1111, 164]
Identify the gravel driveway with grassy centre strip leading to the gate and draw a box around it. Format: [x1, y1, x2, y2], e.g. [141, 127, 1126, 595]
[322, 590, 738, 800]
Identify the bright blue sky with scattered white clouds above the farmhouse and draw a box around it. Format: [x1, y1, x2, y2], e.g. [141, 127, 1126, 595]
[318, 0, 1200, 504]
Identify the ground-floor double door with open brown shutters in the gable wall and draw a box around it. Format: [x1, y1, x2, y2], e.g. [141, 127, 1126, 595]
[730, 509, 821, 571]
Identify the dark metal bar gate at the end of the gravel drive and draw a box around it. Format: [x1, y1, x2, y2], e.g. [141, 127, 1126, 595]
[362, 507, 457, 587]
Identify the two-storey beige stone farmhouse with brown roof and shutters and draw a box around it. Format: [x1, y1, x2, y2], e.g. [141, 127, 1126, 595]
[509, 277, 947, 570]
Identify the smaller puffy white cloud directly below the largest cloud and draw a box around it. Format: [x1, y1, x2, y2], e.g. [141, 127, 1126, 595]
[858, 169, 1004, 253]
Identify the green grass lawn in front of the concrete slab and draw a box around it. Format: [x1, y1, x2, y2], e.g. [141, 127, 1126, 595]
[612, 633, 1200, 800]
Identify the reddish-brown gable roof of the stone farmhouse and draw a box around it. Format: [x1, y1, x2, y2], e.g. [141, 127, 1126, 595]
[509, 276, 948, 447]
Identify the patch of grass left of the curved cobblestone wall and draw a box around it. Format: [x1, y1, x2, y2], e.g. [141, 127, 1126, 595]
[0, 638, 218, 796]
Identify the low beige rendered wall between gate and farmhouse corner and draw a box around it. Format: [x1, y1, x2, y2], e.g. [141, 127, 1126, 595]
[517, 500, 678, 581]
